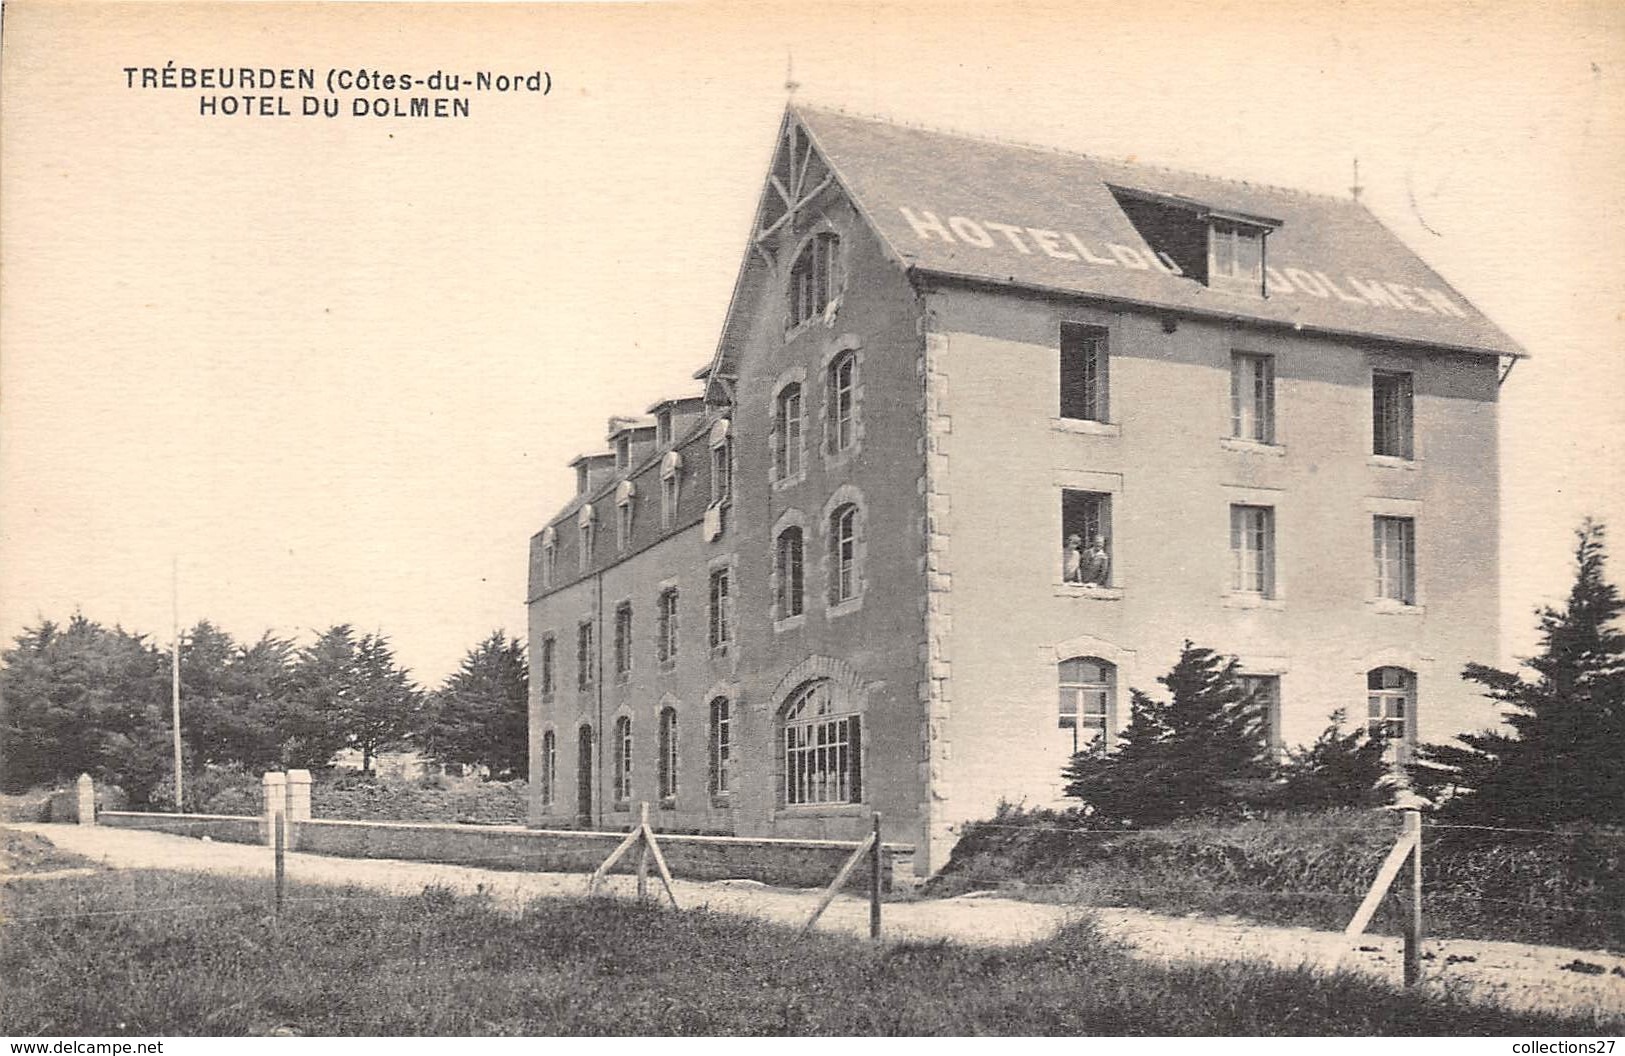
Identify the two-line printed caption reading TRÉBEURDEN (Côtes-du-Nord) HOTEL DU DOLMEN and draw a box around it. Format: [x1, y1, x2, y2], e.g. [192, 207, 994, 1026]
[124, 62, 553, 117]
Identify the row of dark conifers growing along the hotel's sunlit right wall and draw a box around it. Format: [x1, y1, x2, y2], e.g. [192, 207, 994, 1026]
[1063, 522, 1625, 829]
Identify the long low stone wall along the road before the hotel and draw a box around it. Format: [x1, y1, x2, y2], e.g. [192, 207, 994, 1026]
[96, 811, 913, 890]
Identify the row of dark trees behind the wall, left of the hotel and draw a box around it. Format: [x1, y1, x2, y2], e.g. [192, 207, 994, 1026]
[0, 612, 530, 804]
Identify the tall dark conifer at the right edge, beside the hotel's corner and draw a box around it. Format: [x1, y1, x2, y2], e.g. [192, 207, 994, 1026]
[1411, 520, 1625, 829]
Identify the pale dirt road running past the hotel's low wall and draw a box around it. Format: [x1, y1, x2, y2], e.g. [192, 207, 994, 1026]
[8, 824, 1625, 1032]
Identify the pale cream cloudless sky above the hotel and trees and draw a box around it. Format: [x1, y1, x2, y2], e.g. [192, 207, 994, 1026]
[0, 0, 1625, 684]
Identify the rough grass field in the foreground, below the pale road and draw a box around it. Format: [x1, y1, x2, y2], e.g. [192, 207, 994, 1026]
[0, 872, 1618, 1037]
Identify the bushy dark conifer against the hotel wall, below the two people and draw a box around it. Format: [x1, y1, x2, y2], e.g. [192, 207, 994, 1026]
[1063, 642, 1269, 825]
